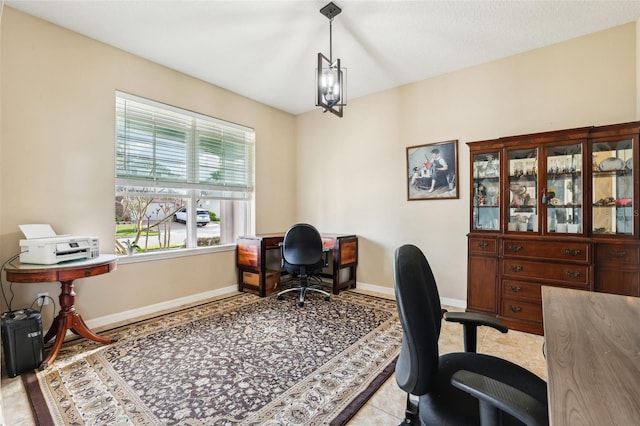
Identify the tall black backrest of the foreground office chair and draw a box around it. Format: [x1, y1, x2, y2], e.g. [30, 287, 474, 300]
[394, 244, 441, 395]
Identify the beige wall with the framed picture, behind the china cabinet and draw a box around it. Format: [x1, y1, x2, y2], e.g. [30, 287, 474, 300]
[296, 24, 636, 300]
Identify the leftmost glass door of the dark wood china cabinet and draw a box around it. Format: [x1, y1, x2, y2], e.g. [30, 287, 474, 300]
[472, 152, 500, 231]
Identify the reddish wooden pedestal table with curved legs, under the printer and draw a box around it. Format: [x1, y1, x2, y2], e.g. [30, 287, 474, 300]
[5, 254, 117, 370]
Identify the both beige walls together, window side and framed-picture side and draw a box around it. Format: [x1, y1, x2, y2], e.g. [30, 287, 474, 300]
[0, 7, 637, 319]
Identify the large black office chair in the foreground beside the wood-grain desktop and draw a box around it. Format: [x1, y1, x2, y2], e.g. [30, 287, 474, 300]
[394, 245, 549, 426]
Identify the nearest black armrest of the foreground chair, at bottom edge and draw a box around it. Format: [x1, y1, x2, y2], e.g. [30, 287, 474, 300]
[451, 370, 549, 426]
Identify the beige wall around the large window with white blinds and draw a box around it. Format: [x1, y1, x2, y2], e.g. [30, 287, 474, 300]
[0, 7, 296, 320]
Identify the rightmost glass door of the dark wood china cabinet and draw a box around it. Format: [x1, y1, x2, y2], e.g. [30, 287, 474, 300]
[591, 139, 634, 235]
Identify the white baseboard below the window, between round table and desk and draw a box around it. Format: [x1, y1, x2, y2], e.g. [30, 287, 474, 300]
[85, 285, 238, 329]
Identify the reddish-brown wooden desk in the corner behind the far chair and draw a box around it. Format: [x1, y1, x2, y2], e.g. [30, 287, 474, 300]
[236, 232, 358, 297]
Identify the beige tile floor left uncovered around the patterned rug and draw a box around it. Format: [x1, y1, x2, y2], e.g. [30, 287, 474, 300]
[1, 292, 547, 426]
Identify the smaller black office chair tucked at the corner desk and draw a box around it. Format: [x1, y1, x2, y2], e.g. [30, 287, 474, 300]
[278, 223, 331, 307]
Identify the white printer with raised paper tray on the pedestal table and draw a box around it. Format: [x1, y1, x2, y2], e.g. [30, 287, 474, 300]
[20, 224, 100, 265]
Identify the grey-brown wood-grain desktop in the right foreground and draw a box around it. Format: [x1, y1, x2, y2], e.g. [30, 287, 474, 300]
[542, 286, 640, 426]
